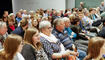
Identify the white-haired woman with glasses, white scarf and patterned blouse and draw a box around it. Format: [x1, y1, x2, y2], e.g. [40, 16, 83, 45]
[39, 21, 78, 60]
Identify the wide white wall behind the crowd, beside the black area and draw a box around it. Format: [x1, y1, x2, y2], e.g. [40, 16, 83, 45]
[12, 0, 66, 13]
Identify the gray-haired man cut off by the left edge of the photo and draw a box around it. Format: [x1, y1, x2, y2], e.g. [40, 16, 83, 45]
[0, 21, 7, 49]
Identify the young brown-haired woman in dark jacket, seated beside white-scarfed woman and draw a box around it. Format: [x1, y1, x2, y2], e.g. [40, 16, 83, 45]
[21, 28, 48, 60]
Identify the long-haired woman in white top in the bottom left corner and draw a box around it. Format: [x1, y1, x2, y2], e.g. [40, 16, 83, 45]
[0, 34, 25, 60]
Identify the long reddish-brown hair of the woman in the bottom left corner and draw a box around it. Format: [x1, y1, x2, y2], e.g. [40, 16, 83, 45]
[0, 34, 22, 60]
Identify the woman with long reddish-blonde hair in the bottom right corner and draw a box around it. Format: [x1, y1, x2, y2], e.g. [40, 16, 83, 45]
[84, 37, 105, 60]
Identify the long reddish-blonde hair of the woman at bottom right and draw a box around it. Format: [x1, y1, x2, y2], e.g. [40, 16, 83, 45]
[84, 37, 105, 60]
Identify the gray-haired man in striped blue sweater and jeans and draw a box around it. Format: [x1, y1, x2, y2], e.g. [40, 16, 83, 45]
[52, 18, 86, 60]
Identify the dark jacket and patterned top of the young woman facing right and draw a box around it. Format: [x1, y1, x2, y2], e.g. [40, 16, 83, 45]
[21, 44, 48, 60]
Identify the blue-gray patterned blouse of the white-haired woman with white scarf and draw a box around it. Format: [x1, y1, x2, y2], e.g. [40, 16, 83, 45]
[40, 37, 61, 60]
